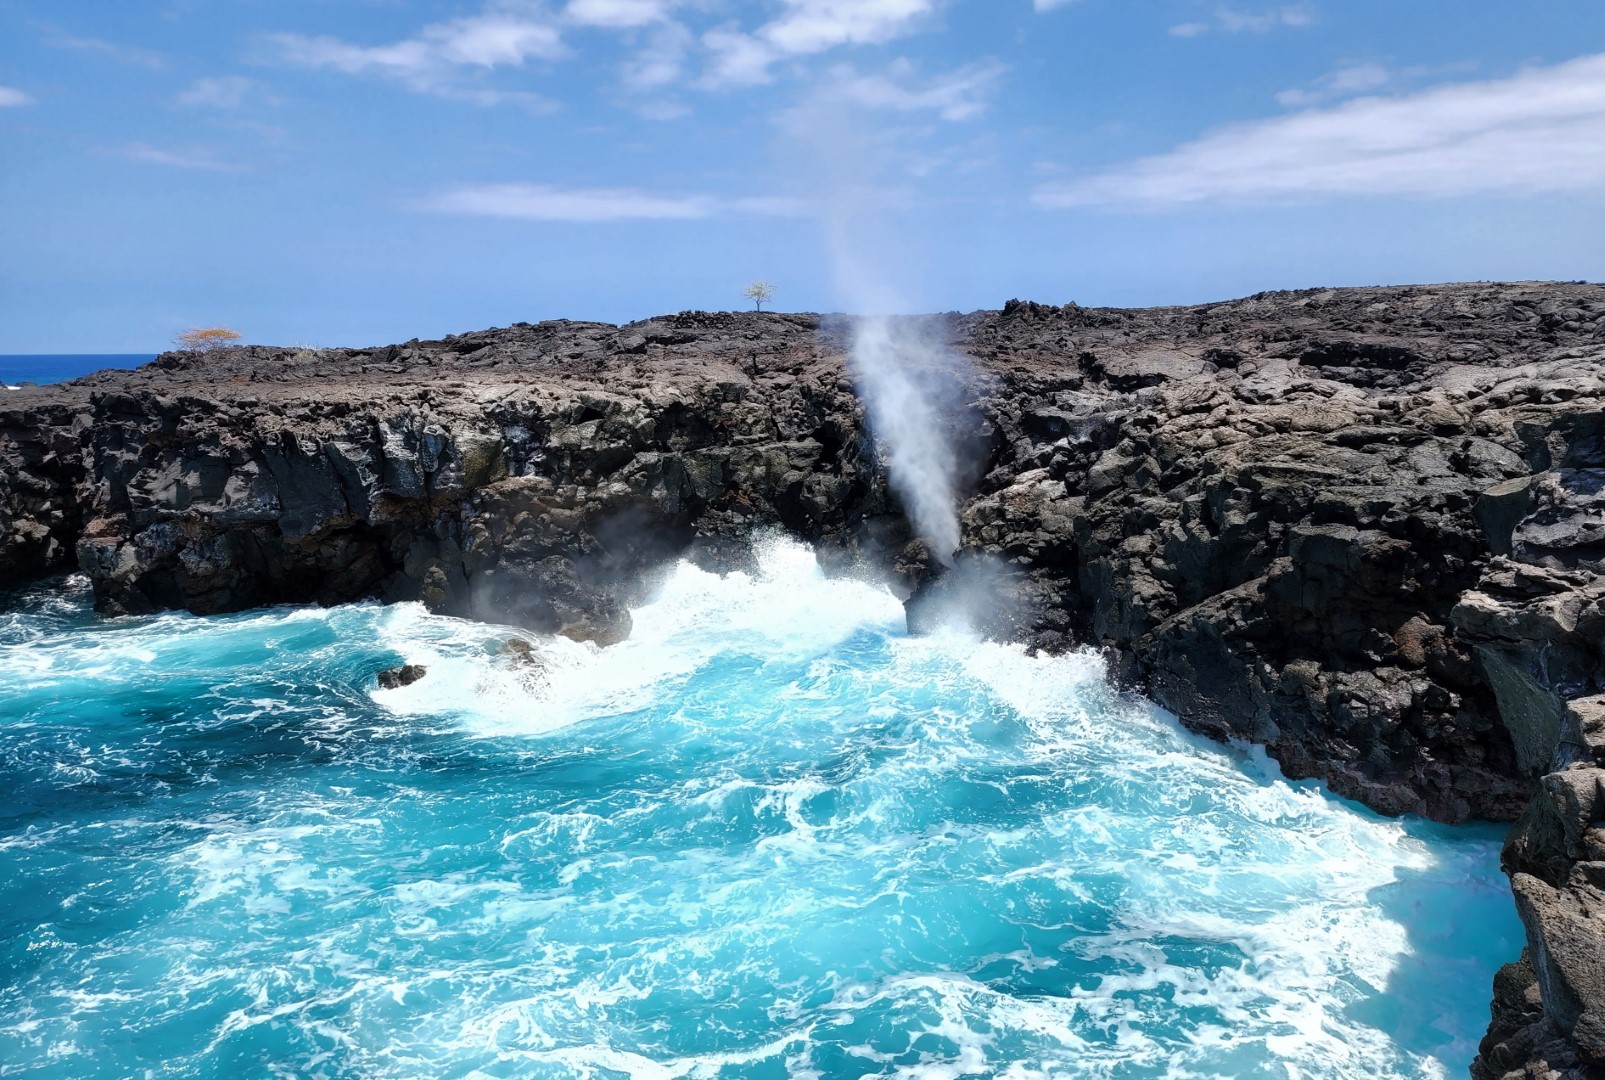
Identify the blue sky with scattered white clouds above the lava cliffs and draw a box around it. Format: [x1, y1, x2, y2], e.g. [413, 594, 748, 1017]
[0, 0, 1605, 353]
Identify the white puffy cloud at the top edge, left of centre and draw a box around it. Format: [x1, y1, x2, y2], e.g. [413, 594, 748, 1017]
[271, 5, 565, 101]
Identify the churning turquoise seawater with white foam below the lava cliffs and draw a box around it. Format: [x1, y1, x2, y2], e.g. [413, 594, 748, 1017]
[0, 544, 1520, 1078]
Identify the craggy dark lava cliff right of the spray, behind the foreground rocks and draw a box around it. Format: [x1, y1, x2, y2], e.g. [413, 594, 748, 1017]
[966, 286, 1605, 822]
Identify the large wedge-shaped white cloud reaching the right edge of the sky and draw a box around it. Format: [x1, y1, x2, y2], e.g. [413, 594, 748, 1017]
[1035, 53, 1605, 207]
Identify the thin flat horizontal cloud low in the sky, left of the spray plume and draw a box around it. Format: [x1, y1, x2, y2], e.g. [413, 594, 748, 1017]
[411, 183, 798, 223]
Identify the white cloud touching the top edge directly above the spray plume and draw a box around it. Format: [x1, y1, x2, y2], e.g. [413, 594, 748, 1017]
[703, 0, 936, 85]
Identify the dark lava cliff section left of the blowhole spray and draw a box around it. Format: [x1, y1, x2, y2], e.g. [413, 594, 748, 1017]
[0, 316, 907, 644]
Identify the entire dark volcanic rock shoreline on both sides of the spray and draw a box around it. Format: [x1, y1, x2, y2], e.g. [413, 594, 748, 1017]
[0, 284, 1605, 1077]
